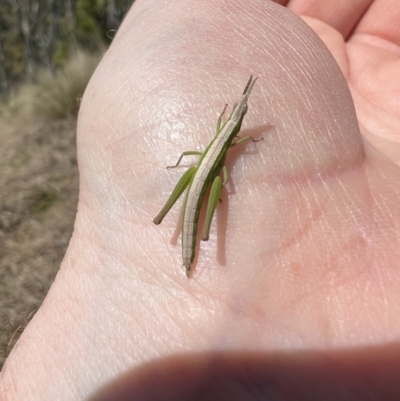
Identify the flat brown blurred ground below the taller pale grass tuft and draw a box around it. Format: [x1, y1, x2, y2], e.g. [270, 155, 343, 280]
[0, 118, 78, 369]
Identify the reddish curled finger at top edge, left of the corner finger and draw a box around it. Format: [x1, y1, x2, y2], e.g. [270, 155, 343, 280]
[287, 0, 374, 38]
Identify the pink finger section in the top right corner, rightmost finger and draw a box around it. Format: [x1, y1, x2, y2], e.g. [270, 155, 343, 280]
[355, 0, 400, 45]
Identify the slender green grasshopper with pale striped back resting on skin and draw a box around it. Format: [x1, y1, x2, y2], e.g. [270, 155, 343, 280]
[153, 76, 262, 277]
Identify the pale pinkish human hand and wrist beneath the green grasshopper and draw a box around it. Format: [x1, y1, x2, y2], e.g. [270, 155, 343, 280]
[0, 0, 400, 401]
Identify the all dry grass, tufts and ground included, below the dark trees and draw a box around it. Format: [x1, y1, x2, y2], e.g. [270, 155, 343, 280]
[0, 45, 98, 368]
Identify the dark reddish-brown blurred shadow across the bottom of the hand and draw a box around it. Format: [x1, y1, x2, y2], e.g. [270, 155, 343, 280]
[89, 343, 400, 401]
